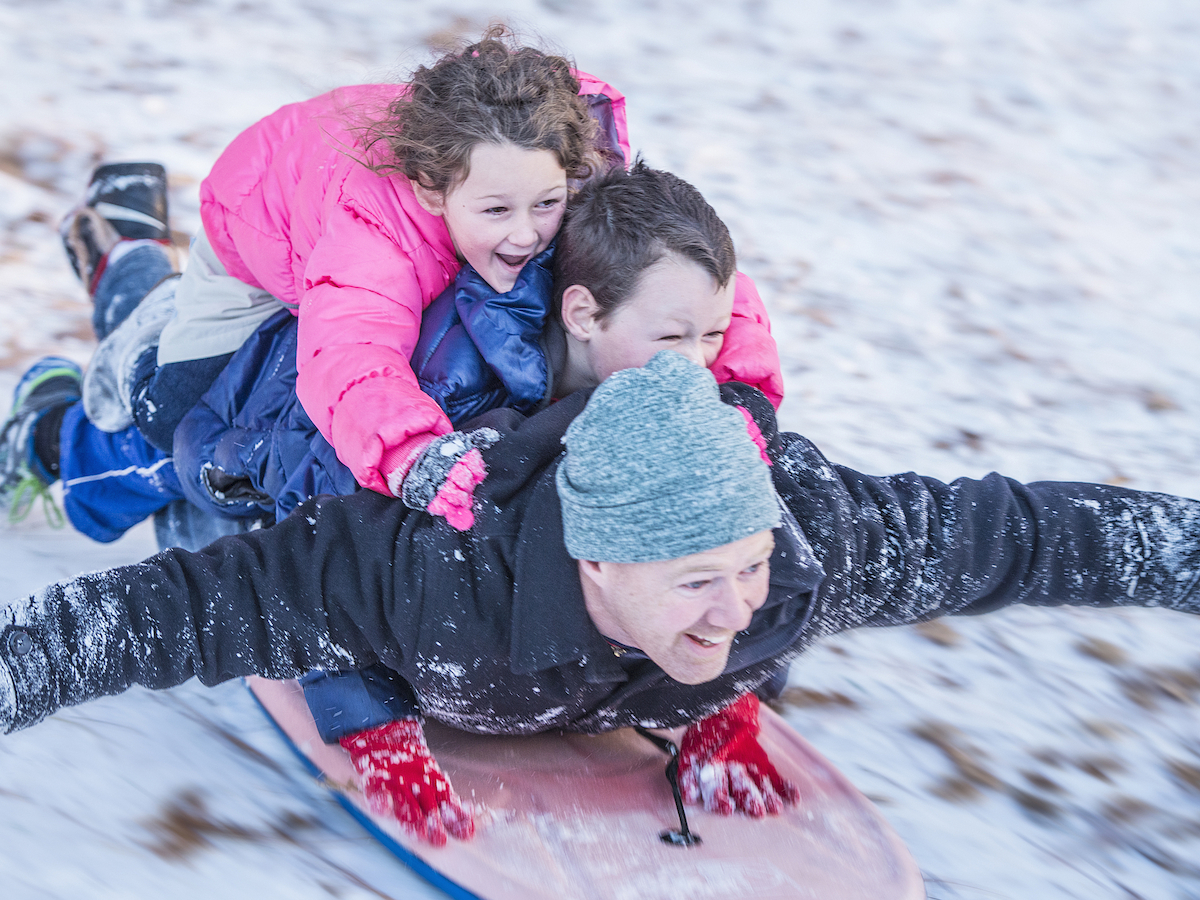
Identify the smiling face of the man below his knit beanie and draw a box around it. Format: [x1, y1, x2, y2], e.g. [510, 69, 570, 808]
[580, 530, 775, 684]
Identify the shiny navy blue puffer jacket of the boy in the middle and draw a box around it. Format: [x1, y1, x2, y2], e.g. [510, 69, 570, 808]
[174, 247, 553, 518]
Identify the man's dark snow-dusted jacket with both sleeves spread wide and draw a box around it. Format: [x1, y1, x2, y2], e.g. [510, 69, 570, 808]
[0, 385, 1200, 733]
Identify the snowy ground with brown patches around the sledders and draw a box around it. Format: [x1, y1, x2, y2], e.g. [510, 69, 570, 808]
[0, 0, 1200, 900]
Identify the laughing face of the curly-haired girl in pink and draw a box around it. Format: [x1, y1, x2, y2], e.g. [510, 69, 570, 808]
[413, 144, 566, 294]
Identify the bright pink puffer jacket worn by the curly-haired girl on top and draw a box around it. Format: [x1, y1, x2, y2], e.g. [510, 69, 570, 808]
[200, 72, 782, 493]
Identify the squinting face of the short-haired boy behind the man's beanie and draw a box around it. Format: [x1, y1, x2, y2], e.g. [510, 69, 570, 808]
[563, 253, 734, 384]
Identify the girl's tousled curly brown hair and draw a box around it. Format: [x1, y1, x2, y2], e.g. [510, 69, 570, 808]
[362, 25, 602, 194]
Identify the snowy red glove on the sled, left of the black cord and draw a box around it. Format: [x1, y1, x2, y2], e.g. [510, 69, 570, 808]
[338, 719, 475, 847]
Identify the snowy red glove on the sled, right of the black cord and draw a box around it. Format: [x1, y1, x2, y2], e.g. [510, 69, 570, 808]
[679, 694, 800, 817]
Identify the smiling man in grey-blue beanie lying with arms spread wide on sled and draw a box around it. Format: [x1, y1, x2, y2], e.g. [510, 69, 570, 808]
[0, 353, 1200, 841]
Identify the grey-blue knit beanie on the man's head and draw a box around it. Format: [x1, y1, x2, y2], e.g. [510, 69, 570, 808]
[557, 350, 780, 563]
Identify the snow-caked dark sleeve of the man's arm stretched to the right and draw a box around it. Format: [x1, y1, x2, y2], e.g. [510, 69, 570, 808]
[772, 424, 1200, 634]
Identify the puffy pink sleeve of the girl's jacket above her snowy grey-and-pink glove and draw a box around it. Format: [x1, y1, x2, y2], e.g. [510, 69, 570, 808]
[296, 211, 451, 494]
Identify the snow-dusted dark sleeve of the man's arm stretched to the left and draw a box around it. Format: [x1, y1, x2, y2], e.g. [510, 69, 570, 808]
[0, 491, 419, 732]
